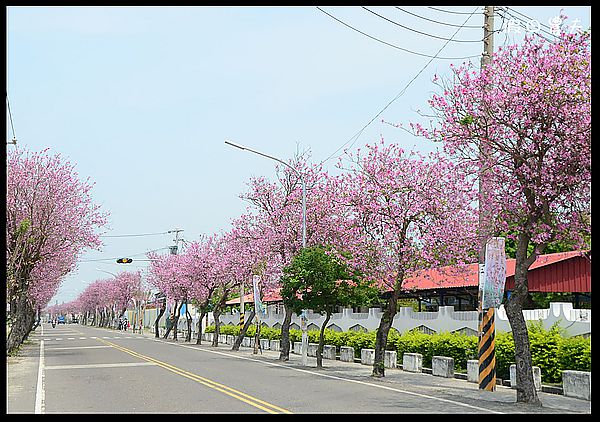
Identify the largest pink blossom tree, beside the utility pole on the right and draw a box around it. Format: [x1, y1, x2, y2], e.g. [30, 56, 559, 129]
[414, 33, 591, 405]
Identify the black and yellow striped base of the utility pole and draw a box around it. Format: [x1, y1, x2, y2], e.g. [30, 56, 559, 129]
[478, 308, 496, 391]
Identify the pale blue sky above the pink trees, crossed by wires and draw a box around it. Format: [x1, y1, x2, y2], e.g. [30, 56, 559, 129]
[6, 5, 591, 305]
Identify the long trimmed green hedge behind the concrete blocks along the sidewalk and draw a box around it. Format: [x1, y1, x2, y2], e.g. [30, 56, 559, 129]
[206, 322, 592, 383]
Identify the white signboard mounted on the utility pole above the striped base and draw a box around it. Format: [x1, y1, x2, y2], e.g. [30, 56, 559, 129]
[479, 237, 506, 309]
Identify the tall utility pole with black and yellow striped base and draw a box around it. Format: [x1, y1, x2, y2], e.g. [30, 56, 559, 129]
[478, 6, 496, 391]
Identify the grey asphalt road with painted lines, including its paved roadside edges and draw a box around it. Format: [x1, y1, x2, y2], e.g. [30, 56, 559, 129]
[7, 324, 591, 414]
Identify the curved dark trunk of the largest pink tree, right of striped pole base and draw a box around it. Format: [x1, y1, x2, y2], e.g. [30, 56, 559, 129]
[506, 234, 542, 406]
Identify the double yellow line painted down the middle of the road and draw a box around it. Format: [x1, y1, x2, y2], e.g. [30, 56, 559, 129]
[97, 338, 292, 414]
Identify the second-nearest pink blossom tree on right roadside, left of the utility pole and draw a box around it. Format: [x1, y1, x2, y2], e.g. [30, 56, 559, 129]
[342, 141, 477, 377]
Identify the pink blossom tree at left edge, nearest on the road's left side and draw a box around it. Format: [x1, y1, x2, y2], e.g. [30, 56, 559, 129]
[6, 148, 106, 351]
